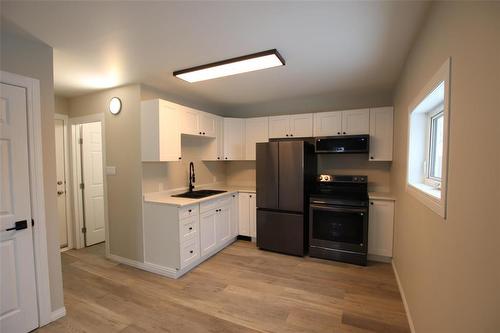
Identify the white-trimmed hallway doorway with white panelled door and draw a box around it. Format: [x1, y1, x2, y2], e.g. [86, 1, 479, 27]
[71, 117, 107, 248]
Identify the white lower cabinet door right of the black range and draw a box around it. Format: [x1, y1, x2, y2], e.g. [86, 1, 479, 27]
[368, 200, 394, 257]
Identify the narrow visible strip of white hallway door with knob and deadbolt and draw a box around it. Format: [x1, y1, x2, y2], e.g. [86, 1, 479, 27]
[54, 119, 68, 247]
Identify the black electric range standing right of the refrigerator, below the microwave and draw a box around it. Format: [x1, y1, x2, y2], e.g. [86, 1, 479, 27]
[309, 175, 369, 265]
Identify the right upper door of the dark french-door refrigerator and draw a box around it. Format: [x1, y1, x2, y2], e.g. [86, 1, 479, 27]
[278, 141, 304, 212]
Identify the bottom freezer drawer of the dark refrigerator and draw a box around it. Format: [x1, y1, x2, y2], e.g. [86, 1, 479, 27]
[257, 209, 305, 256]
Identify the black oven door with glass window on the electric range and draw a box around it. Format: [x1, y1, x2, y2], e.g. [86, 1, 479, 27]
[309, 204, 368, 253]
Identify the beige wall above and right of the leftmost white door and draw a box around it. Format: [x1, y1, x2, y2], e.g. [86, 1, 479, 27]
[0, 20, 64, 310]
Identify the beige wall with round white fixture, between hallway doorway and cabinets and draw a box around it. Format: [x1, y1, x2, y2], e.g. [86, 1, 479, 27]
[69, 85, 143, 261]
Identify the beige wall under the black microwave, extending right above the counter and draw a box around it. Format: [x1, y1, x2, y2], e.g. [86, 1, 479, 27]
[318, 154, 391, 192]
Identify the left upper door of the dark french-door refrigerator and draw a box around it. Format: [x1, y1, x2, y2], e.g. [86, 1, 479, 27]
[255, 142, 279, 209]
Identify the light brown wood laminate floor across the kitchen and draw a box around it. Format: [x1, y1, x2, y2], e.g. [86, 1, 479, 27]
[38, 241, 410, 333]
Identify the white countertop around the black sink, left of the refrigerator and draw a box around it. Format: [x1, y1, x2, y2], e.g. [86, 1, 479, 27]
[143, 185, 255, 207]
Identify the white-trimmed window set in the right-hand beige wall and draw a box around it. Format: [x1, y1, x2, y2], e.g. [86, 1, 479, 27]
[406, 60, 450, 217]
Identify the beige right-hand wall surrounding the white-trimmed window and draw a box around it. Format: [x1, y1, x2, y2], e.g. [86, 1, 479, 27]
[391, 2, 500, 333]
